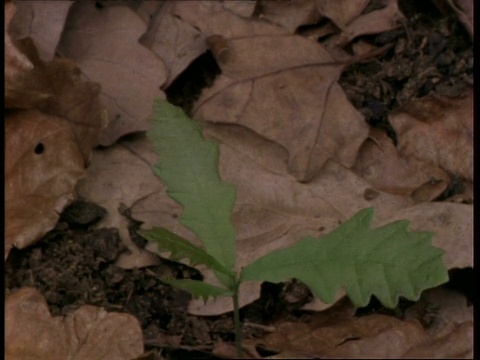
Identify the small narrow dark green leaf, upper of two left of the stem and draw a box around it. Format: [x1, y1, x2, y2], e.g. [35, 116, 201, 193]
[138, 228, 235, 278]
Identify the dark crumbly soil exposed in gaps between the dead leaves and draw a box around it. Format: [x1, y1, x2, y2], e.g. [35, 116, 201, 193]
[5, 1, 473, 359]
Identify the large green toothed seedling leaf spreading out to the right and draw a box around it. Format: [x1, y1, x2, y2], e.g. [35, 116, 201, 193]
[240, 208, 448, 307]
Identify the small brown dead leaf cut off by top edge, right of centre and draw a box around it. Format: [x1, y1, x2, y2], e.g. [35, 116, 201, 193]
[258, 0, 320, 34]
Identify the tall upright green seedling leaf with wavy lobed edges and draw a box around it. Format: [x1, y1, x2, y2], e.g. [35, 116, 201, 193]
[148, 100, 236, 271]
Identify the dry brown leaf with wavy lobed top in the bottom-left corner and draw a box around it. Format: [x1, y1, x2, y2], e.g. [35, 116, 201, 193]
[5, 288, 143, 360]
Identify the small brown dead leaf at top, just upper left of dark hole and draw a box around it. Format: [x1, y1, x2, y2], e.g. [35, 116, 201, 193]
[137, 2, 207, 88]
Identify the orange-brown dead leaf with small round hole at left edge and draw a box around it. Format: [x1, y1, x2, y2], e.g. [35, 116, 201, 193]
[5, 110, 84, 256]
